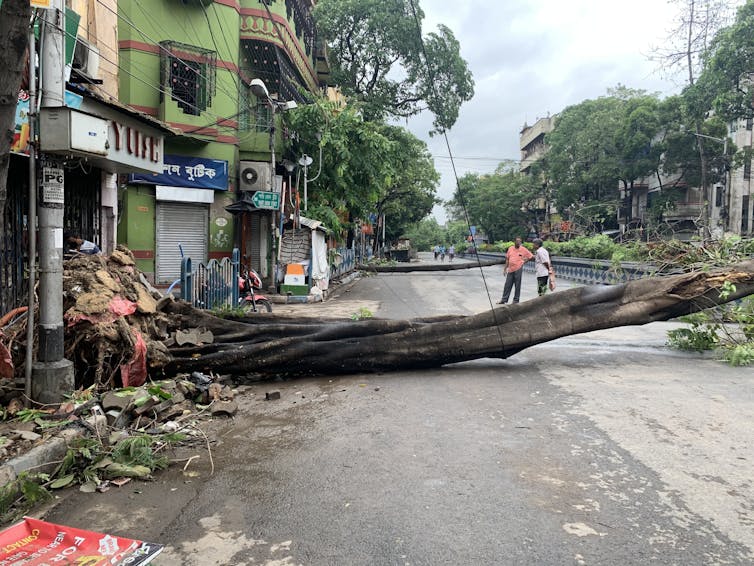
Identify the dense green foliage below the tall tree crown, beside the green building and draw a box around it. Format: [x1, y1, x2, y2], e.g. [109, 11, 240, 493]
[286, 99, 440, 244]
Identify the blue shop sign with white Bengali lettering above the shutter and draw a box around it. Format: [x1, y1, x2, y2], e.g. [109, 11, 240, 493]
[129, 155, 228, 191]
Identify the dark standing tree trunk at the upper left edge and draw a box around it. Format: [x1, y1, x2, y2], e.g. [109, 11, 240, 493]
[0, 0, 31, 237]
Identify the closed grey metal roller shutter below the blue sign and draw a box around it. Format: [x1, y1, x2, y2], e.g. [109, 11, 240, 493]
[155, 202, 209, 283]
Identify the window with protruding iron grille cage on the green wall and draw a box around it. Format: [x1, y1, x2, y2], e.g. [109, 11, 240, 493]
[160, 41, 217, 116]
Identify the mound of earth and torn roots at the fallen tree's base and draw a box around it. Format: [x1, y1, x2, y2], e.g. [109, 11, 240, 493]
[0, 246, 187, 390]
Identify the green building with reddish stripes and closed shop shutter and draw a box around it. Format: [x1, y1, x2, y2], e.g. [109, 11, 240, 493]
[118, 0, 327, 285]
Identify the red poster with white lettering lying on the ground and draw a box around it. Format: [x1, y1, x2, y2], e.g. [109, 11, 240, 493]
[0, 517, 163, 566]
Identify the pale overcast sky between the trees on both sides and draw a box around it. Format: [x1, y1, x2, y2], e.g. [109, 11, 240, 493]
[407, 0, 680, 223]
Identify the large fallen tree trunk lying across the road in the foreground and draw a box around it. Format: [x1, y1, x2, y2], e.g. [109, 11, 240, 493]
[165, 260, 754, 382]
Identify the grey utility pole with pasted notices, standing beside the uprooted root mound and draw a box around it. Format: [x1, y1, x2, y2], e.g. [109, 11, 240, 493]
[30, 0, 75, 403]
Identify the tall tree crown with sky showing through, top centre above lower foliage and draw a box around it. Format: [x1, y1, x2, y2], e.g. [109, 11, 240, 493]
[314, 0, 474, 132]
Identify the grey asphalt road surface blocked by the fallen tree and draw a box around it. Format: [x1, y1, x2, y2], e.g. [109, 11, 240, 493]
[48, 255, 754, 566]
